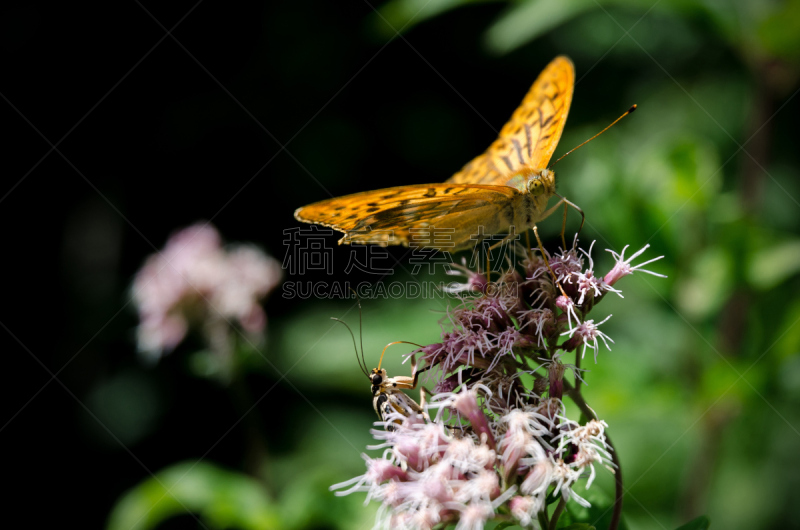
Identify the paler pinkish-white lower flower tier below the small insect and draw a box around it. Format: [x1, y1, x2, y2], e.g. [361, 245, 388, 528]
[331, 385, 613, 529]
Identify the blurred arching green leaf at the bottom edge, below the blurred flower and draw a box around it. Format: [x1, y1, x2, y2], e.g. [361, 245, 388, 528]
[106, 462, 282, 530]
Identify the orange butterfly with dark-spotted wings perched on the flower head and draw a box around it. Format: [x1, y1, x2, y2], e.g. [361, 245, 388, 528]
[294, 56, 575, 251]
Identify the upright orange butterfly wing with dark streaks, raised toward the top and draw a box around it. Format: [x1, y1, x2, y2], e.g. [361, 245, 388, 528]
[447, 55, 575, 185]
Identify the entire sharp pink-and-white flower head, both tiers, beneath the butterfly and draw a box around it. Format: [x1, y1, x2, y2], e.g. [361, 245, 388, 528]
[332, 238, 661, 529]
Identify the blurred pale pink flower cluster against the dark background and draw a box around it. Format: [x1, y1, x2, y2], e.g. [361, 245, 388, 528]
[132, 223, 281, 358]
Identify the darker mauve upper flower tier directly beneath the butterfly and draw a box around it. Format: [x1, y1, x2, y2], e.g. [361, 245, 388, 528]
[421, 238, 664, 373]
